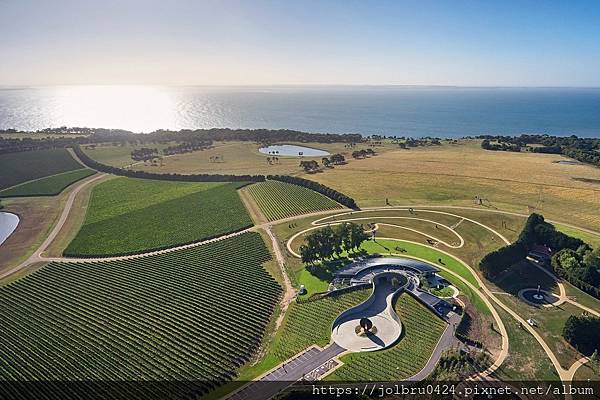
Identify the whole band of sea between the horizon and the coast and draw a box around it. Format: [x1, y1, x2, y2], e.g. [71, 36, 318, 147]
[0, 86, 600, 137]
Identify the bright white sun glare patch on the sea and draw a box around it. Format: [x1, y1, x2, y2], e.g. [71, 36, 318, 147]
[53, 86, 178, 132]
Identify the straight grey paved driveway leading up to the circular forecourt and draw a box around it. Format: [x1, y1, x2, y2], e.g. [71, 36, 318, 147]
[228, 343, 345, 400]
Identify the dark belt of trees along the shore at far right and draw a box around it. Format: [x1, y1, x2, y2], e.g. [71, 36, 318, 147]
[477, 135, 600, 166]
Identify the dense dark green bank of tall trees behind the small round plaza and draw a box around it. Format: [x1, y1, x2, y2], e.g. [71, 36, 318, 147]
[479, 213, 589, 279]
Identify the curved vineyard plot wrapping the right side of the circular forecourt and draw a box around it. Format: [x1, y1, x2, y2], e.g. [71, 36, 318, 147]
[327, 293, 446, 381]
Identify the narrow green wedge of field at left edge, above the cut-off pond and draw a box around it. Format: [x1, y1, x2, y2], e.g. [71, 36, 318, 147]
[0, 168, 96, 197]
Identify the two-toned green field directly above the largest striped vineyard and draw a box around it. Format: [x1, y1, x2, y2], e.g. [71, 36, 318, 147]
[64, 178, 252, 257]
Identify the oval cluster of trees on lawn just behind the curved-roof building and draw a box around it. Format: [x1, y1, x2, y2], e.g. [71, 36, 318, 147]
[300, 222, 369, 264]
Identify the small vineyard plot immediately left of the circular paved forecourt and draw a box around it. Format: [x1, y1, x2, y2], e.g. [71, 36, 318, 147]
[271, 289, 371, 361]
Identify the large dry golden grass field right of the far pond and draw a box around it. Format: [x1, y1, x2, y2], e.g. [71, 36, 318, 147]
[310, 141, 600, 229]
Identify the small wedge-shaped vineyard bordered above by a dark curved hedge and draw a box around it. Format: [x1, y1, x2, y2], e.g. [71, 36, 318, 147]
[248, 181, 341, 221]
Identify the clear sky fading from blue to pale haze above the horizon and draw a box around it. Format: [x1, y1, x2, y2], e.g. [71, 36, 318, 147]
[0, 0, 600, 87]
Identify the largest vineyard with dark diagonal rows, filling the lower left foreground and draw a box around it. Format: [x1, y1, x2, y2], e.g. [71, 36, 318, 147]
[0, 233, 281, 398]
